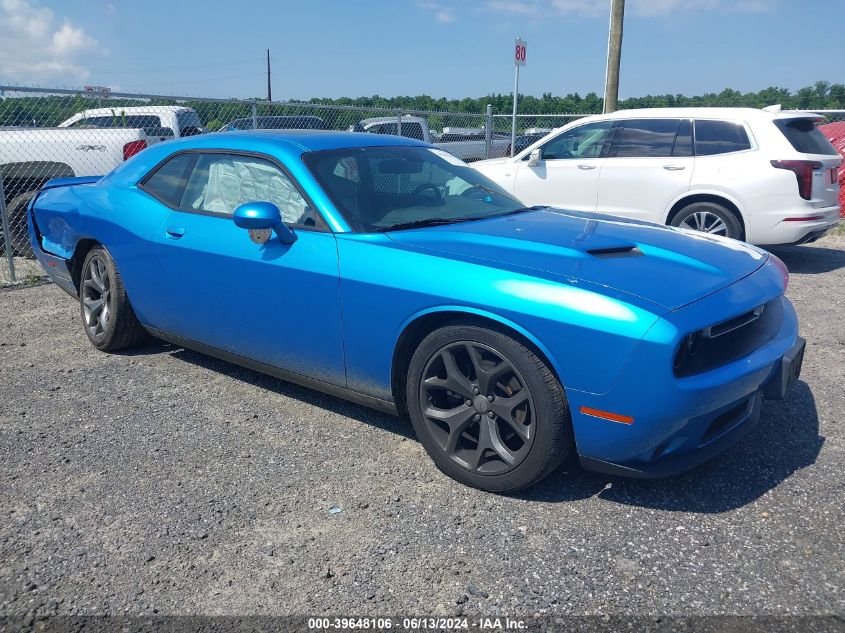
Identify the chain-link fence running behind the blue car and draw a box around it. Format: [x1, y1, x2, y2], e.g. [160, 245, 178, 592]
[0, 85, 845, 285]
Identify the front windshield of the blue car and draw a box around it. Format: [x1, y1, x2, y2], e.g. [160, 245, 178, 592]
[303, 146, 524, 233]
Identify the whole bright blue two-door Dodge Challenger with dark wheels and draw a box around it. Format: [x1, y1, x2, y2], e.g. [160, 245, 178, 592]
[28, 131, 804, 492]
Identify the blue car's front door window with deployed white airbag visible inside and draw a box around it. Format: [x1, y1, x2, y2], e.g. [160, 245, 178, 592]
[178, 153, 318, 226]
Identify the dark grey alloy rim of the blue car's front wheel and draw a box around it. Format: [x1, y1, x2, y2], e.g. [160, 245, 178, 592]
[420, 341, 534, 474]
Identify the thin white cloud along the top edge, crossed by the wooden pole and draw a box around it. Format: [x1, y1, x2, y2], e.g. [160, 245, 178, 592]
[486, 0, 779, 18]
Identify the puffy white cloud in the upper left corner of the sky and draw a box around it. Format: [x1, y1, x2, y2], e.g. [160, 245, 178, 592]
[0, 0, 106, 84]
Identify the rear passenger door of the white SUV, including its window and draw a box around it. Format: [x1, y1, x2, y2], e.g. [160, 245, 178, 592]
[596, 118, 695, 222]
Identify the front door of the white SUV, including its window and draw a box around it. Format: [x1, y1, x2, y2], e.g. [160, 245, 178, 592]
[513, 121, 613, 211]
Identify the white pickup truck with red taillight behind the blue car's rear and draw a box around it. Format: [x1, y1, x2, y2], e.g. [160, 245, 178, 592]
[0, 128, 152, 255]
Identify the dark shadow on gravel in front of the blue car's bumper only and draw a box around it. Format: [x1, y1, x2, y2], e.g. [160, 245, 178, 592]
[520, 381, 824, 513]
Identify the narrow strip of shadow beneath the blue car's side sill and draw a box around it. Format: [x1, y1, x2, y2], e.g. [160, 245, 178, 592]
[124, 341, 416, 439]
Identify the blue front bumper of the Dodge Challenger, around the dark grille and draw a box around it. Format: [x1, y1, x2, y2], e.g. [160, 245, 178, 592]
[567, 266, 805, 477]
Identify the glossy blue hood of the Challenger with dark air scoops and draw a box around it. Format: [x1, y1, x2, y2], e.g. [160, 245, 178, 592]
[388, 209, 768, 310]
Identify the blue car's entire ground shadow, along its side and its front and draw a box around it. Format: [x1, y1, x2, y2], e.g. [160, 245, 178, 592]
[123, 342, 825, 513]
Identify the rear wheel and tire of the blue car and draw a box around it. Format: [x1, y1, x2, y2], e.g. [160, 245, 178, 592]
[79, 246, 146, 352]
